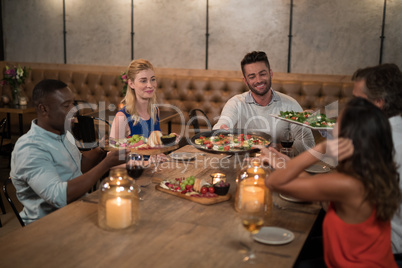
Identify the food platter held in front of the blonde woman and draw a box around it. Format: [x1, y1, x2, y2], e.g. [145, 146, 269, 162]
[103, 131, 179, 155]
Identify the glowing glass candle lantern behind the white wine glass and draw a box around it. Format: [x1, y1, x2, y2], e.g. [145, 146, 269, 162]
[235, 159, 272, 213]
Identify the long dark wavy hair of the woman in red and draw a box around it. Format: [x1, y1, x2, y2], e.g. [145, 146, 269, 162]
[337, 98, 401, 221]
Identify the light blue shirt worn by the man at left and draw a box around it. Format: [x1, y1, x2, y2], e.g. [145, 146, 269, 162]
[10, 120, 82, 224]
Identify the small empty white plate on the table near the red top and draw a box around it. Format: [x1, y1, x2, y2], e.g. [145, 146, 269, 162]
[253, 227, 295, 245]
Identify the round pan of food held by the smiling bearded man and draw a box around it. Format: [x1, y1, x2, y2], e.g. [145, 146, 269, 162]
[190, 129, 272, 154]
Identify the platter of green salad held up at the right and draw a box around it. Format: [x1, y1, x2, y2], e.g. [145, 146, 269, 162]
[270, 111, 336, 130]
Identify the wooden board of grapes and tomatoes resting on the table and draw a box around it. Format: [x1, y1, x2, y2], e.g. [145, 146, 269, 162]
[155, 176, 232, 205]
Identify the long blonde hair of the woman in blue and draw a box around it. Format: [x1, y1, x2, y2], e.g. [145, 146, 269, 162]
[121, 59, 157, 125]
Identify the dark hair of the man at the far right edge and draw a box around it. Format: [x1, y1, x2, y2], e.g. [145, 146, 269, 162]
[352, 63, 402, 117]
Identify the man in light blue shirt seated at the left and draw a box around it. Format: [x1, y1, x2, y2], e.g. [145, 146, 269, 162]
[10, 80, 125, 224]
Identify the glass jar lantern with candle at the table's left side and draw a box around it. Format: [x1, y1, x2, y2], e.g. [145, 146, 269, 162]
[98, 168, 139, 230]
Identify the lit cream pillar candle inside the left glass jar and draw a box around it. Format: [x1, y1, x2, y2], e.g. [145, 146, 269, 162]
[106, 197, 132, 229]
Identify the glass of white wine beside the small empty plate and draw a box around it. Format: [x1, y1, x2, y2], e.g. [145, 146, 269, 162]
[240, 199, 265, 263]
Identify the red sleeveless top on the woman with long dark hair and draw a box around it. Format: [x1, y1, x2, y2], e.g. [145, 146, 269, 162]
[323, 203, 398, 268]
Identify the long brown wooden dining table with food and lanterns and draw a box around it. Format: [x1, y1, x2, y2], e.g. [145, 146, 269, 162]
[0, 145, 321, 267]
